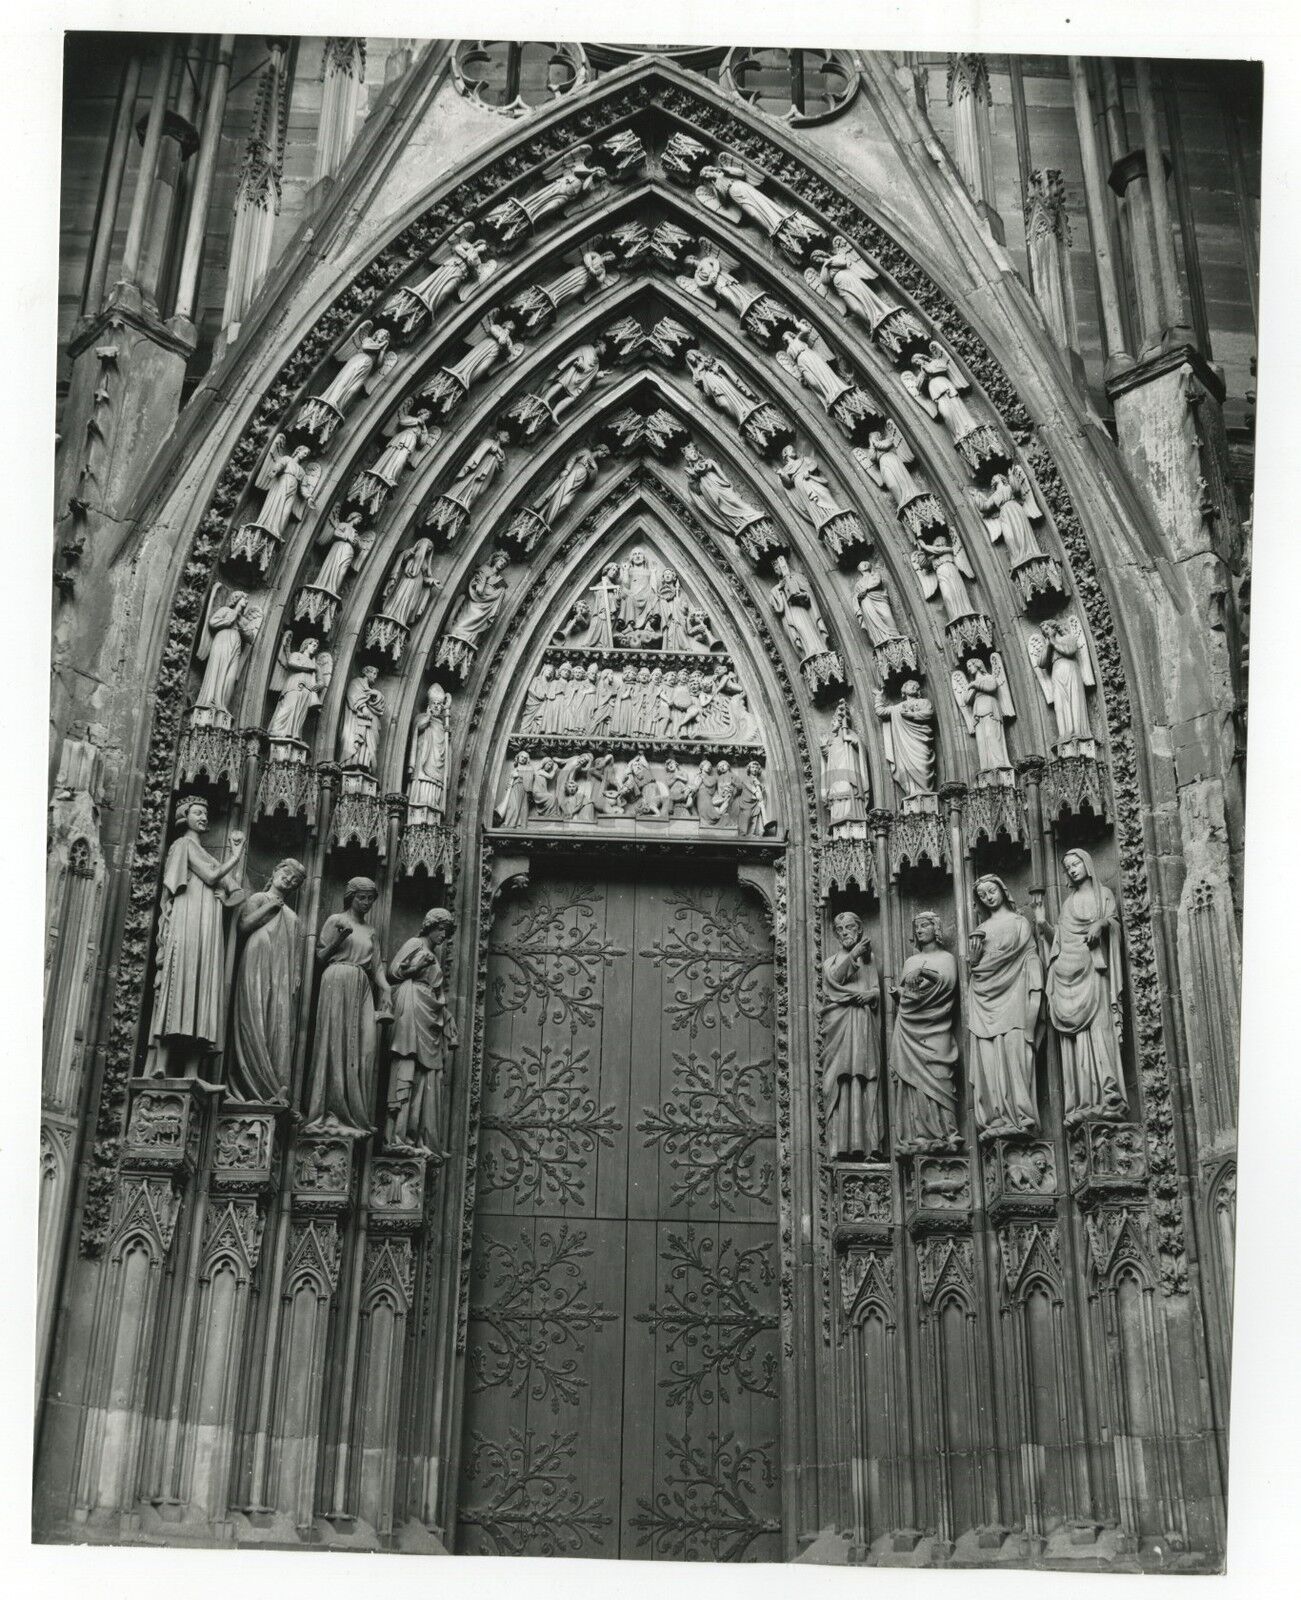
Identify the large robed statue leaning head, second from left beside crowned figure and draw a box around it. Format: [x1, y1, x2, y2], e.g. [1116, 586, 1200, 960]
[227, 861, 307, 1104]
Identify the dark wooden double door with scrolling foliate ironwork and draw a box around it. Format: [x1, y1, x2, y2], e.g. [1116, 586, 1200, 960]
[458, 877, 783, 1562]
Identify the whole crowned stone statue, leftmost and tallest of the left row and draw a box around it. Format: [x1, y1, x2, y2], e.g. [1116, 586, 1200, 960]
[144, 795, 243, 1078]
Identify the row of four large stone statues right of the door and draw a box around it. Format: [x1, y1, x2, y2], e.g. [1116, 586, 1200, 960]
[821, 850, 1128, 1162]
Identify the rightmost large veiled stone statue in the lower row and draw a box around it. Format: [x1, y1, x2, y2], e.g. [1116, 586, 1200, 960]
[1035, 850, 1128, 1126]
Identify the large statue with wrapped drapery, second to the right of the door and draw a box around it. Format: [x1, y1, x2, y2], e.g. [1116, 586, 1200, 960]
[890, 910, 959, 1155]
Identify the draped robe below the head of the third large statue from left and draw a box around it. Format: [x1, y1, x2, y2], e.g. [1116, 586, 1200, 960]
[307, 915, 381, 1133]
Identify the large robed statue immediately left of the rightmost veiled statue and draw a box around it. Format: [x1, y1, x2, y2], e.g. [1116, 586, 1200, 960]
[967, 872, 1043, 1139]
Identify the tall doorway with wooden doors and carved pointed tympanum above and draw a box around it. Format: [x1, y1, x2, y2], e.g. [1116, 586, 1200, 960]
[456, 517, 784, 1562]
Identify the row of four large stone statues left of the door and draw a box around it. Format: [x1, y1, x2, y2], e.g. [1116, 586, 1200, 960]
[144, 795, 458, 1155]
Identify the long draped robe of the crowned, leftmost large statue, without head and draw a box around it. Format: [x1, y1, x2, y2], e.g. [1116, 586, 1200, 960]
[149, 832, 242, 1053]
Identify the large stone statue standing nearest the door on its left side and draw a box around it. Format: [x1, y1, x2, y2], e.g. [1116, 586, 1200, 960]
[384, 907, 458, 1155]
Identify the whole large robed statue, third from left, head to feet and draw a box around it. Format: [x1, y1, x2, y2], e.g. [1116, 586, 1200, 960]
[306, 878, 390, 1134]
